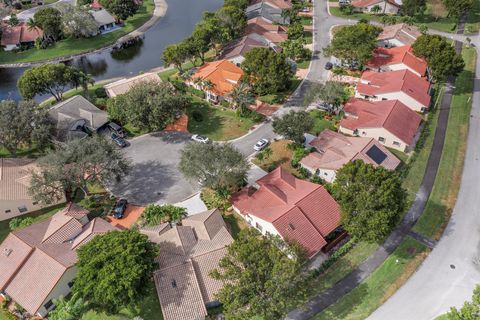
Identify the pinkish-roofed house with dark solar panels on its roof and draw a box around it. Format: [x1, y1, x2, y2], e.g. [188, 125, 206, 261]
[300, 129, 400, 182]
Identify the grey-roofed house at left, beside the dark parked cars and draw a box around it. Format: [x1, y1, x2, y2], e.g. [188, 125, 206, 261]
[48, 96, 109, 142]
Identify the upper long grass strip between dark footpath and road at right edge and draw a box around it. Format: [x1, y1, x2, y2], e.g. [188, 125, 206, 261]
[414, 47, 476, 238]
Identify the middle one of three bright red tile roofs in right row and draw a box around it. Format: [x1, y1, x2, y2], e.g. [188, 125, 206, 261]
[357, 70, 431, 108]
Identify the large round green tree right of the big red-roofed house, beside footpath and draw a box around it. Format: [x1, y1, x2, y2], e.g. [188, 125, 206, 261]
[332, 160, 406, 242]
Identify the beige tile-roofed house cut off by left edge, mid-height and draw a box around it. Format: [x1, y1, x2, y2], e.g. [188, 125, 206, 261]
[0, 158, 64, 221]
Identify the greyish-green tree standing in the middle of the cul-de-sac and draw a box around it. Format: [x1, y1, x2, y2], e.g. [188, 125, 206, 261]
[179, 143, 250, 190]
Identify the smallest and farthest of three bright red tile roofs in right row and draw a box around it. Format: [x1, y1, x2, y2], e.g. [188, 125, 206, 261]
[367, 46, 428, 77]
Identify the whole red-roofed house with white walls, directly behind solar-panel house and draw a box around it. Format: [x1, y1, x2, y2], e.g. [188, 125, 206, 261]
[338, 98, 422, 152]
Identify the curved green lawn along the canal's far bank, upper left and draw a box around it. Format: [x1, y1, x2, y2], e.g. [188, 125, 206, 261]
[0, 0, 155, 64]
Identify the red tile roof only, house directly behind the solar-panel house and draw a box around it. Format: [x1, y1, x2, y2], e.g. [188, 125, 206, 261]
[340, 98, 422, 145]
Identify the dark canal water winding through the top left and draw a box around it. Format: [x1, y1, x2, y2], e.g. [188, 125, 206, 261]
[0, 0, 223, 100]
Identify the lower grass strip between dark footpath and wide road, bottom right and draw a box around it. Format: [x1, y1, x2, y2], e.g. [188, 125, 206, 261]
[312, 237, 428, 320]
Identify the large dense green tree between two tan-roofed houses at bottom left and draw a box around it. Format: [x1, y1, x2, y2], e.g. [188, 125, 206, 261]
[73, 230, 159, 313]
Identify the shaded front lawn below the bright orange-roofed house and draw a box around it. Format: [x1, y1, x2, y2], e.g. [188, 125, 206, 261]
[187, 97, 262, 141]
